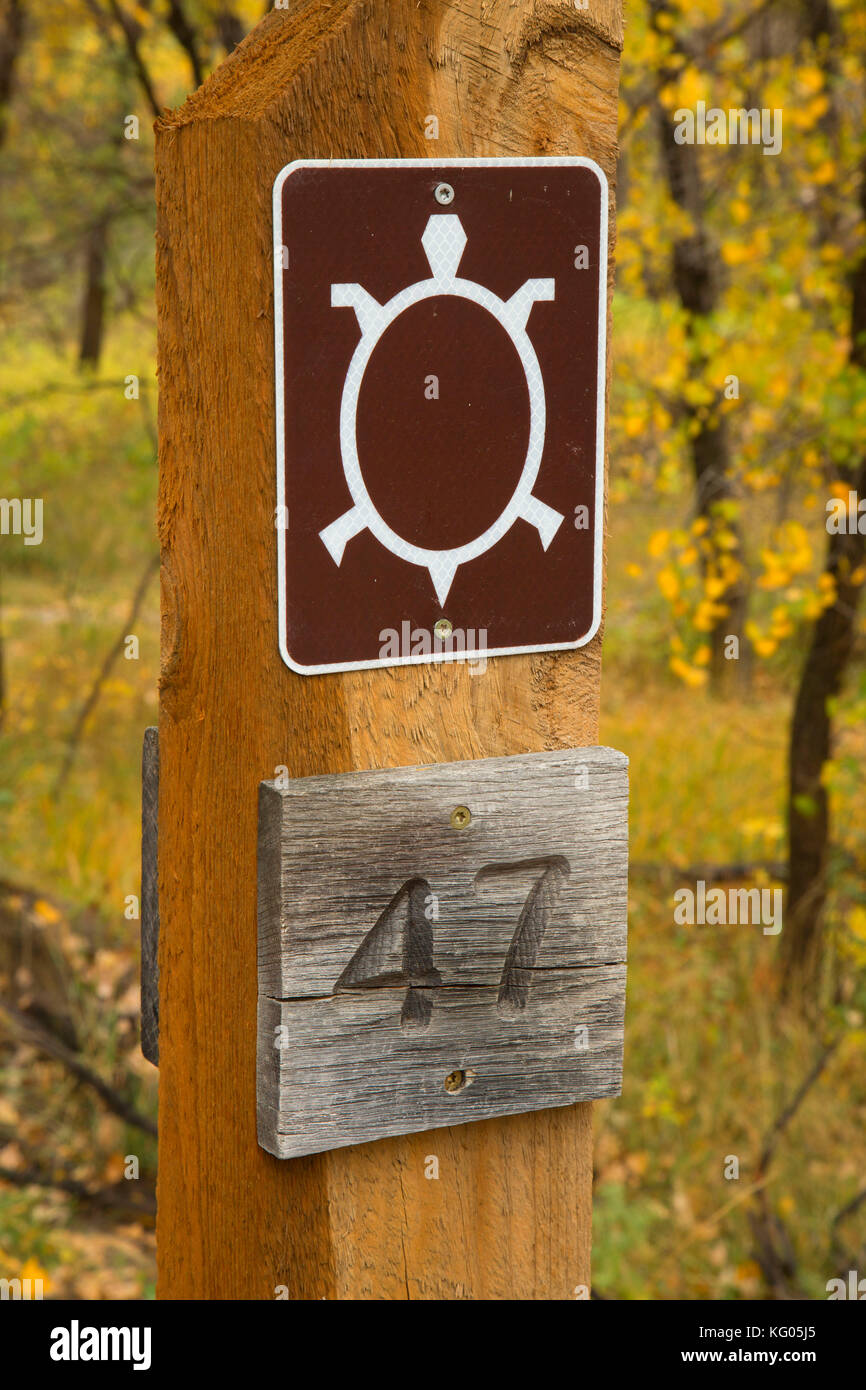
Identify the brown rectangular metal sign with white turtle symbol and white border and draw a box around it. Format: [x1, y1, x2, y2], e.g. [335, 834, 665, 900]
[274, 158, 607, 674]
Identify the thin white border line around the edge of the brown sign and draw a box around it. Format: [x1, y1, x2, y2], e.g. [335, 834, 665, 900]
[272, 154, 609, 676]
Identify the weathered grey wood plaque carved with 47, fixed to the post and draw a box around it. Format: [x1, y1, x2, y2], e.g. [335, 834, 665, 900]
[257, 748, 628, 1158]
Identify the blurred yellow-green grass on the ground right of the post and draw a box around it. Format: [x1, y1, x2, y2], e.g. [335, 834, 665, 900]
[594, 492, 866, 1300]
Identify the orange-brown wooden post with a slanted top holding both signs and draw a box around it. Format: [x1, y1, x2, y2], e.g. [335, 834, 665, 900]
[157, 0, 621, 1300]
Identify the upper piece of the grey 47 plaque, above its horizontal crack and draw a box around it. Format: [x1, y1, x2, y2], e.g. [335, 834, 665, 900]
[259, 748, 628, 999]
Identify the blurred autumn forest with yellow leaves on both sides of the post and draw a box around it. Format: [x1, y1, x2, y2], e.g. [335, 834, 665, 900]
[0, 0, 866, 1298]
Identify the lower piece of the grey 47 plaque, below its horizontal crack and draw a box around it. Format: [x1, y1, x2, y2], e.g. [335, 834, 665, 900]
[257, 965, 626, 1158]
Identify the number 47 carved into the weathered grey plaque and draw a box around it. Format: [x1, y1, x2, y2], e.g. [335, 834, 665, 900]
[334, 858, 569, 1029]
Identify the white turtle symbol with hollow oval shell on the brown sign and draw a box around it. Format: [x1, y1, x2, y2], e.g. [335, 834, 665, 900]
[320, 213, 563, 603]
